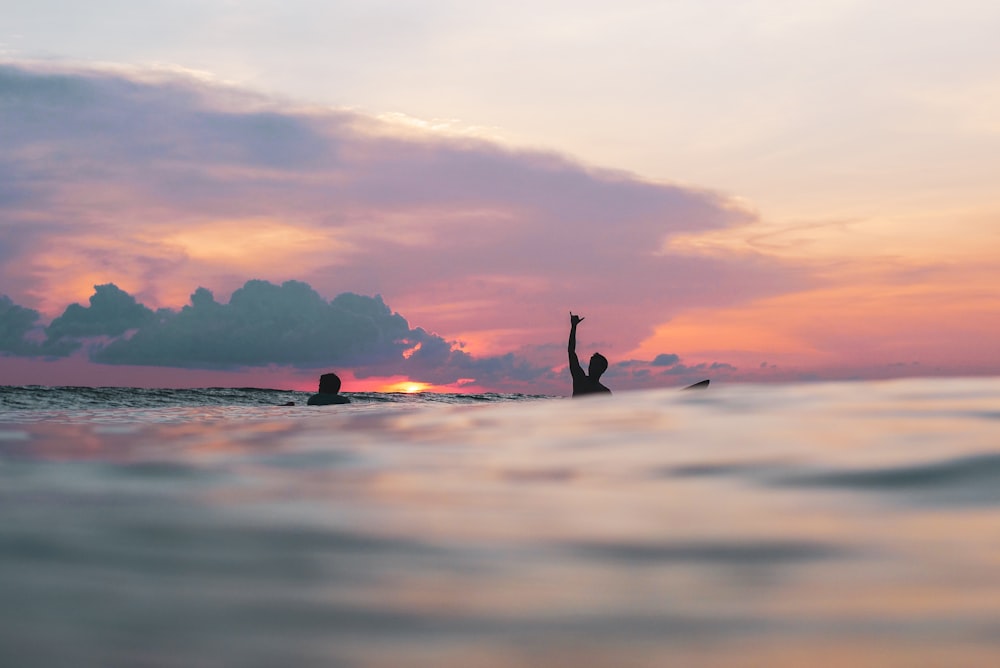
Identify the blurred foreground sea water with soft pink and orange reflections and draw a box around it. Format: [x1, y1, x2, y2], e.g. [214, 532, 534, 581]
[0, 379, 1000, 668]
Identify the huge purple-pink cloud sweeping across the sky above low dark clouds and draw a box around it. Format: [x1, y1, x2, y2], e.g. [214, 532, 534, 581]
[0, 65, 807, 360]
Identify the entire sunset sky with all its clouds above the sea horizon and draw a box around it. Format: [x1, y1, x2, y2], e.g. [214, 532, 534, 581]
[0, 0, 1000, 394]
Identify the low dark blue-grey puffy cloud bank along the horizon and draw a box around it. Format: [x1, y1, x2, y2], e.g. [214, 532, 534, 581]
[0, 280, 732, 387]
